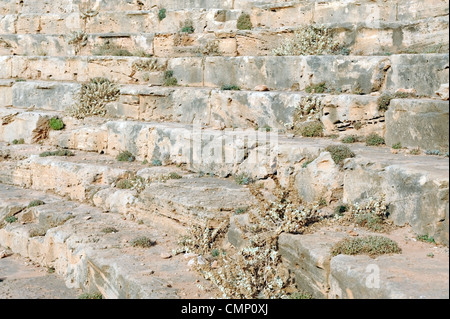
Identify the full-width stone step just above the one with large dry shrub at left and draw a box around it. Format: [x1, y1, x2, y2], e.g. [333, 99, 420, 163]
[0, 54, 449, 96]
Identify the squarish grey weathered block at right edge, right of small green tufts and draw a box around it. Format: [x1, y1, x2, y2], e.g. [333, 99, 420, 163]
[385, 99, 449, 150]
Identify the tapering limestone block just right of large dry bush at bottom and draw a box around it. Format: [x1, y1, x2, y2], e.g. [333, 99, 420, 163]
[278, 233, 345, 298]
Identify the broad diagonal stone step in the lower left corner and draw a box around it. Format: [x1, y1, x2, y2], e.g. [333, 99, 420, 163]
[0, 184, 216, 299]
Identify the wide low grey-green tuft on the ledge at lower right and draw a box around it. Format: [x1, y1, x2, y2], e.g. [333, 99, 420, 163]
[331, 236, 402, 258]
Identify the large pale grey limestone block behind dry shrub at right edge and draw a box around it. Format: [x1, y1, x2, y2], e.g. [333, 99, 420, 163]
[343, 158, 449, 245]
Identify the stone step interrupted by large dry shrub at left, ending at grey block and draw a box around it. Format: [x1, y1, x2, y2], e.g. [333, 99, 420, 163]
[0, 81, 386, 135]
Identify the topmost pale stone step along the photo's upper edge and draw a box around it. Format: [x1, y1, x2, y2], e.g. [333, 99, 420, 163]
[0, 0, 449, 33]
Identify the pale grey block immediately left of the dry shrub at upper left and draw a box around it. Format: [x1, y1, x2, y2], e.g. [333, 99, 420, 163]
[12, 82, 81, 111]
